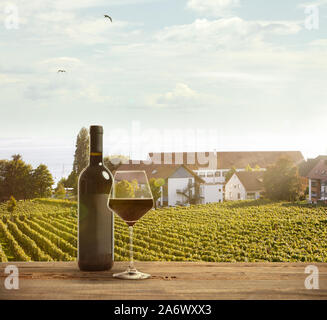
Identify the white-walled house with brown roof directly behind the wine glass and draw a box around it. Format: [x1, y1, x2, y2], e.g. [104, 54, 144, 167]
[117, 160, 205, 206]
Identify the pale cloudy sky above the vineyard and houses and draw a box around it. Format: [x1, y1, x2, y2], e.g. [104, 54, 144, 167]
[0, 0, 327, 179]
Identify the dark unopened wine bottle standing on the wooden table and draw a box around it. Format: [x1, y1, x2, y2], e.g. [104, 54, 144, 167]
[77, 126, 114, 271]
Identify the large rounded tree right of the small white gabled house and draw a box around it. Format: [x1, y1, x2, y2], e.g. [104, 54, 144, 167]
[263, 158, 301, 201]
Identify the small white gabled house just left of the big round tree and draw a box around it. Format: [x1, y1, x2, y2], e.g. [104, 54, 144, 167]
[225, 171, 264, 200]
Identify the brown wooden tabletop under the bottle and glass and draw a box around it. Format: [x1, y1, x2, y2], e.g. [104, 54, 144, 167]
[0, 262, 327, 300]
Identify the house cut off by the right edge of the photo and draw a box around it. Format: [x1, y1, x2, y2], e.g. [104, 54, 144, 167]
[307, 156, 327, 203]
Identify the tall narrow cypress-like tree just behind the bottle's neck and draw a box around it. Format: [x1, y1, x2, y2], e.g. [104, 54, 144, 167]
[73, 128, 90, 176]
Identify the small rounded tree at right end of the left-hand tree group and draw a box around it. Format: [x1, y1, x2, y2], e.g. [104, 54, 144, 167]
[32, 164, 54, 198]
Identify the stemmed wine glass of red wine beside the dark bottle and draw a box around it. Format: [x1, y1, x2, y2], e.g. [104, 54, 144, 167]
[109, 171, 154, 280]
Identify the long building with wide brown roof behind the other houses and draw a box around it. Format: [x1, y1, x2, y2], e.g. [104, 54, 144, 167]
[149, 151, 304, 202]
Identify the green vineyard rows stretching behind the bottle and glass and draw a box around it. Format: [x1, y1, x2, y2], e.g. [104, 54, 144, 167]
[0, 199, 327, 262]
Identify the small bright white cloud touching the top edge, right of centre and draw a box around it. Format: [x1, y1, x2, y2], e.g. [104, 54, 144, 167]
[187, 0, 239, 17]
